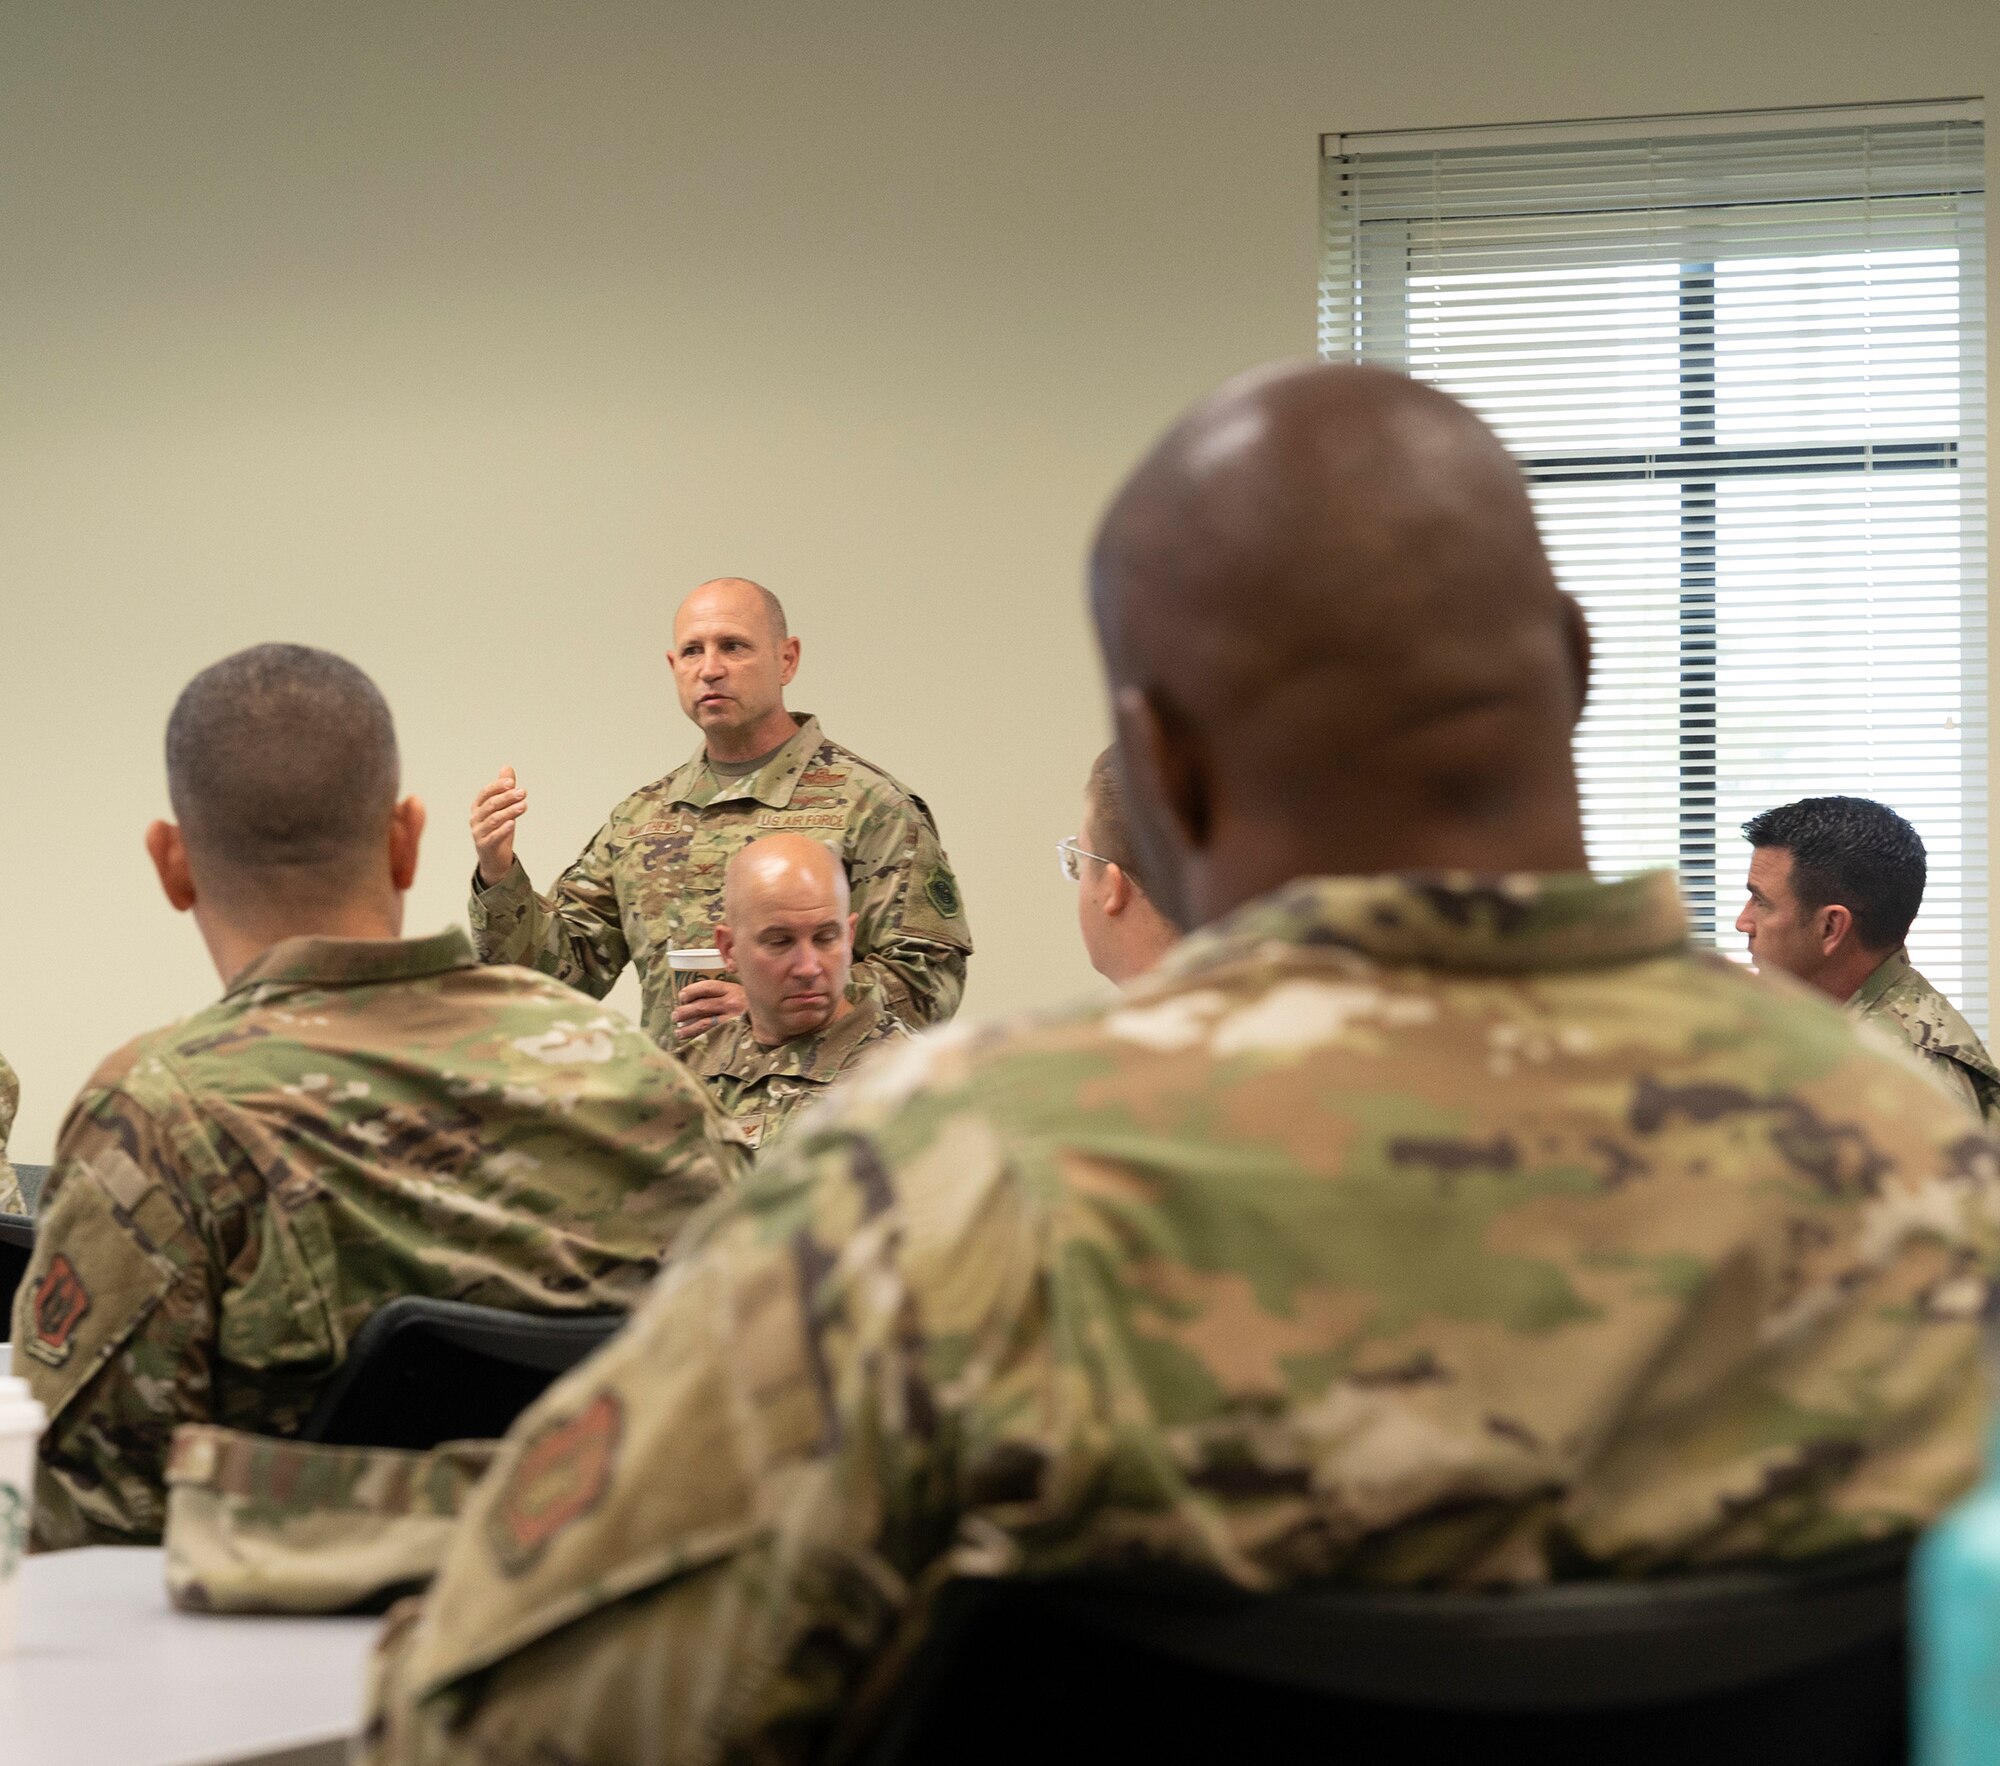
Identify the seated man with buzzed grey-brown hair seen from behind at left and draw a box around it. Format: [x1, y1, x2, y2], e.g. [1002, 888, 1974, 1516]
[14, 644, 742, 1548]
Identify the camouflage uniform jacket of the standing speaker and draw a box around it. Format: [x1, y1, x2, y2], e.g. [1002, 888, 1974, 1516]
[470, 718, 972, 1048]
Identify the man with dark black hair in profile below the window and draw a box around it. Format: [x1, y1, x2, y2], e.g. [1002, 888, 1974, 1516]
[1736, 798, 2000, 1128]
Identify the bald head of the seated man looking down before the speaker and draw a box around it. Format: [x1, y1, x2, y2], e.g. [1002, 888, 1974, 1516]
[716, 834, 854, 1046]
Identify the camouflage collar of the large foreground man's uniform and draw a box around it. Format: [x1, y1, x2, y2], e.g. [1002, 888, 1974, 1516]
[1148, 870, 1688, 992]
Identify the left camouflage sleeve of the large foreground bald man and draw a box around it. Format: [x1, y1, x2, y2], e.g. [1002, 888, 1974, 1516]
[358, 1134, 1034, 1766]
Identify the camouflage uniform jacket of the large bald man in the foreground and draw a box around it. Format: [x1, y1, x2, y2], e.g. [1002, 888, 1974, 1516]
[360, 876, 2000, 1766]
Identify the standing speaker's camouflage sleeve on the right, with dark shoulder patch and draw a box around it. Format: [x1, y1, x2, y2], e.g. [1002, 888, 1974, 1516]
[848, 794, 972, 1030]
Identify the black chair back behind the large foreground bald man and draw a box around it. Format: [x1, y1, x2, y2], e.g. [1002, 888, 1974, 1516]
[860, 1542, 1908, 1766]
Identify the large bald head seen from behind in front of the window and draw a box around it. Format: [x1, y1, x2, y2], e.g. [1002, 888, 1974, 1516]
[1090, 364, 1586, 924]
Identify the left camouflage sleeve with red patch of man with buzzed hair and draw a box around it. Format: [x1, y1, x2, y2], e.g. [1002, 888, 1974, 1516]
[14, 1088, 233, 1550]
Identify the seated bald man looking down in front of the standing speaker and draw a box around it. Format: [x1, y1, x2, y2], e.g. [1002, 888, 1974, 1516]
[684, 834, 910, 1150]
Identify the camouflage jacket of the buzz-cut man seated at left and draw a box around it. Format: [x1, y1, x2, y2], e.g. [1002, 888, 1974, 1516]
[14, 930, 742, 1548]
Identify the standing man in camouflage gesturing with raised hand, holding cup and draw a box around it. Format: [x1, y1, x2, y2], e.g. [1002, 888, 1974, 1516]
[470, 576, 972, 1046]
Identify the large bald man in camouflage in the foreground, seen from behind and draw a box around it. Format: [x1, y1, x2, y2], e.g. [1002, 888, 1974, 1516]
[364, 366, 2000, 1766]
